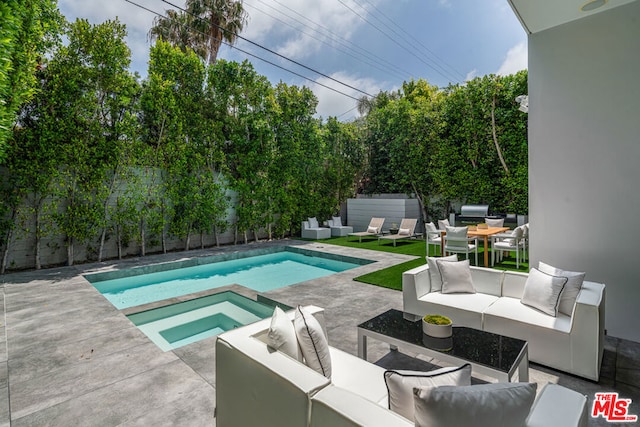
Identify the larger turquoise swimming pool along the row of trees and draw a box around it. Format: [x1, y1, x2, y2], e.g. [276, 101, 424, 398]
[85, 246, 372, 309]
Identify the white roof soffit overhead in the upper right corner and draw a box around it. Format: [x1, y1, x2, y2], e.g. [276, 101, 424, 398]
[508, 0, 639, 34]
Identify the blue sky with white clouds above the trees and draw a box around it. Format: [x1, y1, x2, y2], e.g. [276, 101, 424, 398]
[58, 0, 527, 121]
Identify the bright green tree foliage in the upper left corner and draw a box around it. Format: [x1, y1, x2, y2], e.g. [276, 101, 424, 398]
[0, 0, 64, 159]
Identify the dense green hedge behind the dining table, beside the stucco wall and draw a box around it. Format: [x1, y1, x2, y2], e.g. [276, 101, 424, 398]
[362, 71, 528, 219]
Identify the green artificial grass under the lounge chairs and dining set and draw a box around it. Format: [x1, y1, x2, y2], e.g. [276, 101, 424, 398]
[322, 237, 529, 291]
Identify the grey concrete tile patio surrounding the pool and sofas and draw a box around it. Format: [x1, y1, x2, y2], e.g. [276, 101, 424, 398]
[0, 240, 640, 426]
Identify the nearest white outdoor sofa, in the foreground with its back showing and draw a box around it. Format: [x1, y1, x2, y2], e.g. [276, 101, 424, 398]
[215, 306, 587, 427]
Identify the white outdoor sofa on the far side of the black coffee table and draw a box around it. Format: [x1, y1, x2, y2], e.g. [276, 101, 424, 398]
[402, 265, 605, 381]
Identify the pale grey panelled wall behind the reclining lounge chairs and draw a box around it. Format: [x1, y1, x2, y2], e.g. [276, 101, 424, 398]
[347, 195, 424, 232]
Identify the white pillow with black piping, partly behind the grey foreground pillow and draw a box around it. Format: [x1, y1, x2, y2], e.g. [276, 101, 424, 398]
[384, 363, 471, 421]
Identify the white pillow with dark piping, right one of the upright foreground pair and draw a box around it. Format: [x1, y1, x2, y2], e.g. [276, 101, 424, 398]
[293, 306, 331, 378]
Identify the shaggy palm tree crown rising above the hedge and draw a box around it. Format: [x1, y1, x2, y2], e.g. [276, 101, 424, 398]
[149, 0, 247, 64]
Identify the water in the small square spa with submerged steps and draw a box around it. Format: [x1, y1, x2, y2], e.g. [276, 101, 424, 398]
[127, 291, 282, 351]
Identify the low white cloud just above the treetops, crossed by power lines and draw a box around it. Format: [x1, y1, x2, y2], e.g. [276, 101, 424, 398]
[309, 72, 390, 121]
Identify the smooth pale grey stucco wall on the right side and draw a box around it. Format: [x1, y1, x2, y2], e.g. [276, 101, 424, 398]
[529, 1, 640, 342]
